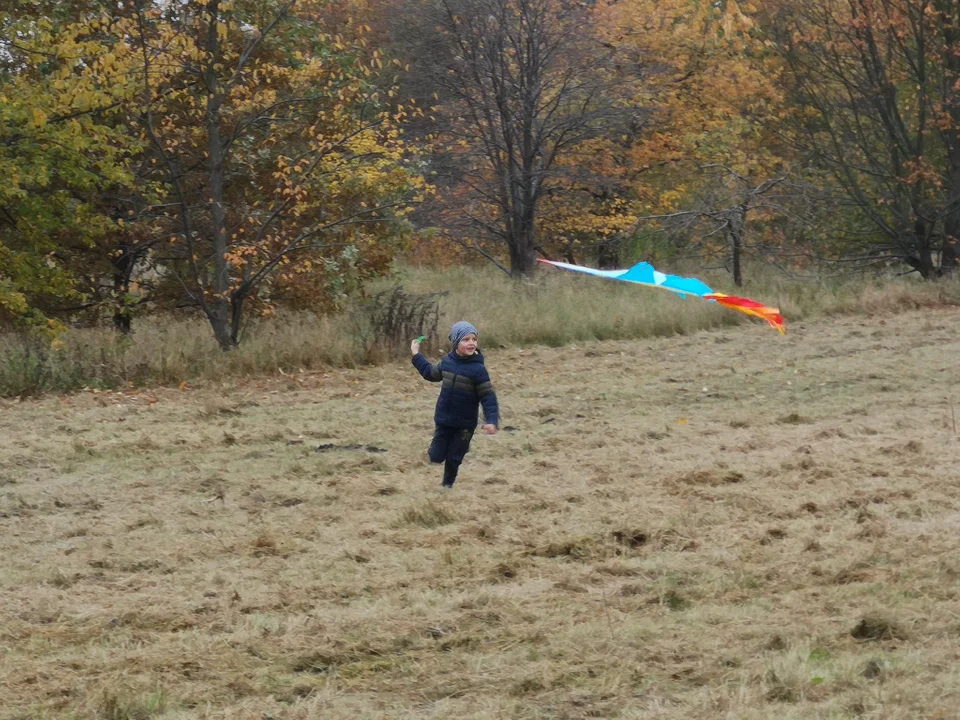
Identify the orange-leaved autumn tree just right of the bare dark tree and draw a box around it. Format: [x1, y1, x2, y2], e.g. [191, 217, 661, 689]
[594, 0, 806, 285]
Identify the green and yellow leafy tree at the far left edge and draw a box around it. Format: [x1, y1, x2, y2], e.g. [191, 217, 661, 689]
[0, 2, 144, 328]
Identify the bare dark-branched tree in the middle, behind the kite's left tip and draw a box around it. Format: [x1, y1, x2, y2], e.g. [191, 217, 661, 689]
[421, 0, 632, 276]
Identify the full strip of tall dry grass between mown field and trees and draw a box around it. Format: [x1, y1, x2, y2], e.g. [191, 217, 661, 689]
[0, 267, 960, 397]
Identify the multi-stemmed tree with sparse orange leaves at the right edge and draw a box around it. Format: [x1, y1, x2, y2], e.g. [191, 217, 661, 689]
[762, 0, 960, 278]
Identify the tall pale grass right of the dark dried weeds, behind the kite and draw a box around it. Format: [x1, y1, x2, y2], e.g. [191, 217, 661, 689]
[397, 265, 960, 347]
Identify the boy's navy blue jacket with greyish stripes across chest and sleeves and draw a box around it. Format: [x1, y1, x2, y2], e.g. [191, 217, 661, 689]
[413, 350, 500, 429]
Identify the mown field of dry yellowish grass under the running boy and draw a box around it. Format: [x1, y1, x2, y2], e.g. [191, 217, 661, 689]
[0, 309, 960, 720]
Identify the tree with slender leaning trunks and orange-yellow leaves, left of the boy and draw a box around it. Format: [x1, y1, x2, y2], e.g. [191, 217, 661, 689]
[113, 0, 427, 349]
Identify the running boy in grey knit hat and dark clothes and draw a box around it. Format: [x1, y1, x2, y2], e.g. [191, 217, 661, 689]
[410, 320, 500, 490]
